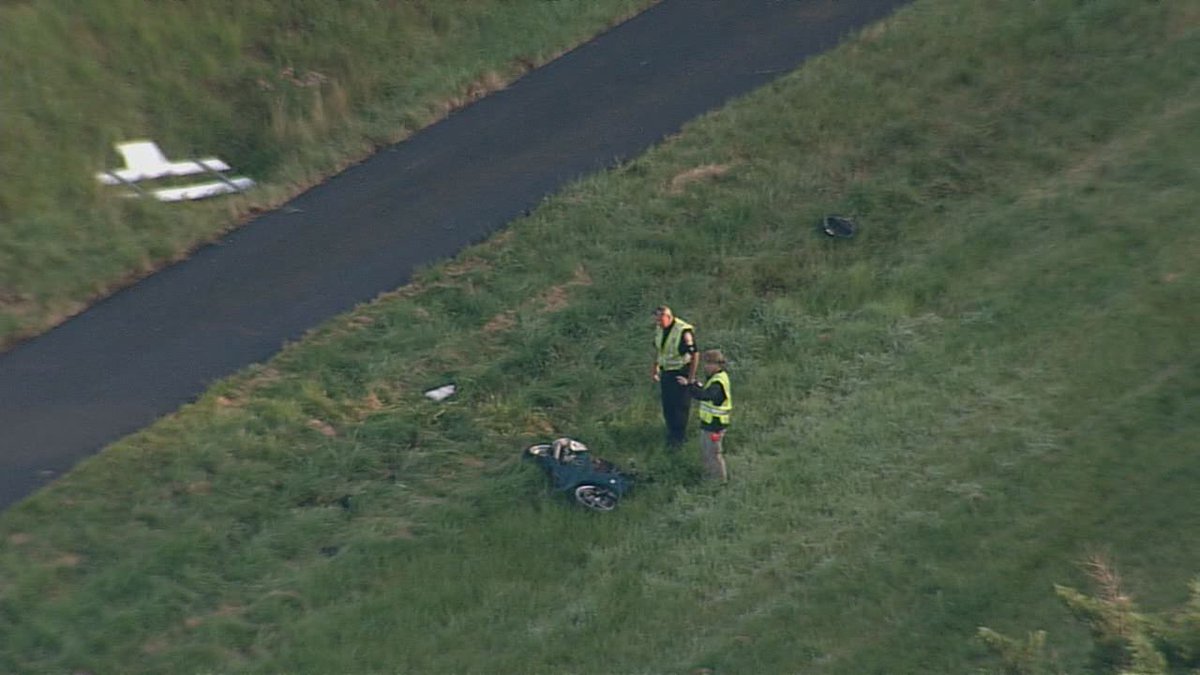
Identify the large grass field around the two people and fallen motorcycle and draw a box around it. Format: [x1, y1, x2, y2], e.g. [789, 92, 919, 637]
[0, 0, 1200, 675]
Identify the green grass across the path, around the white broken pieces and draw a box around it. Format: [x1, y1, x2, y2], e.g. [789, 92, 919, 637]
[0, 0, 652, 347]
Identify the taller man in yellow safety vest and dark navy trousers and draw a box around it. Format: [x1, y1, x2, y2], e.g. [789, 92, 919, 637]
[650, 305, 700, 448]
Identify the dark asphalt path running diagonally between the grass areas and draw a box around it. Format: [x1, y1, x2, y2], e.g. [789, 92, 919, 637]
[0, 0, 906, 508]
